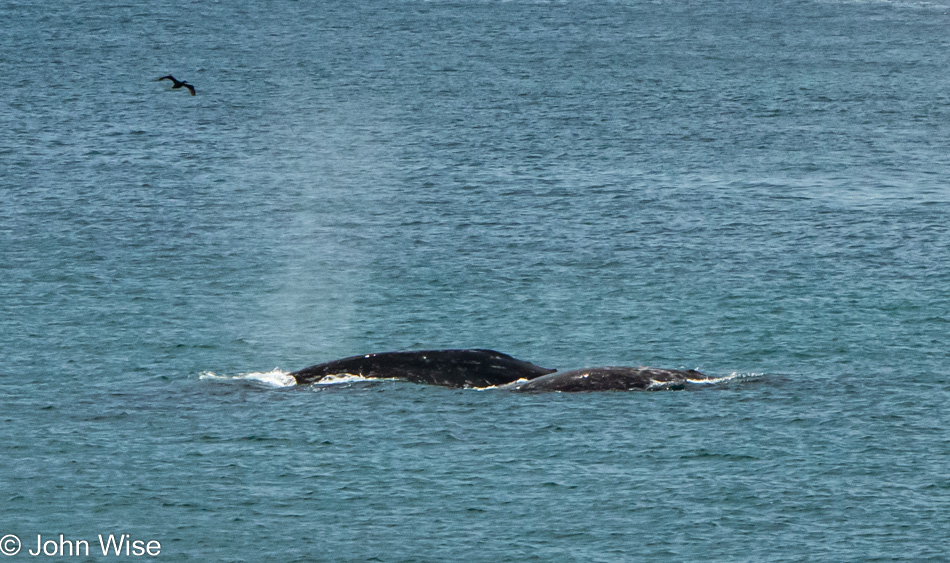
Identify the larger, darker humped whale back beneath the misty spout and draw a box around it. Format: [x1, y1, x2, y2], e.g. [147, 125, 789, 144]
[290, 349, 556, 388]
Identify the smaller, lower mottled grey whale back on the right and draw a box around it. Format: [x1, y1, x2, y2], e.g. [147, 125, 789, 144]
[506, 366, 713, 393]
